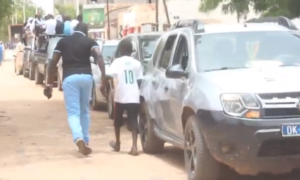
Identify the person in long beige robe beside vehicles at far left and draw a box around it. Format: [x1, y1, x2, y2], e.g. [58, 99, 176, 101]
[14, 42, 25, 75]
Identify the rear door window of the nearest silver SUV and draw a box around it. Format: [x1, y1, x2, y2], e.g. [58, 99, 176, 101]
[159, 34, 177, 69]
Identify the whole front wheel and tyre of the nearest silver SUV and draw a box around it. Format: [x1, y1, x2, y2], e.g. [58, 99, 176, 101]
[184, 115, 221, 180]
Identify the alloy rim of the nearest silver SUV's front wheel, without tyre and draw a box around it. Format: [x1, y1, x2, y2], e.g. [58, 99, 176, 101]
[185, 128, 197, 175]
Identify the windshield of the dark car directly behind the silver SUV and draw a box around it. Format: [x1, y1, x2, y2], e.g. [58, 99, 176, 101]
[141, 36, 159, 59]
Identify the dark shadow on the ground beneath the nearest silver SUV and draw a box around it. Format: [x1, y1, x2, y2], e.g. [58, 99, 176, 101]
[153, 146, 300, 180]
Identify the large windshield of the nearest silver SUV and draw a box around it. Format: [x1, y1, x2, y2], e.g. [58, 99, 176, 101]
[196, 31, 300, 71]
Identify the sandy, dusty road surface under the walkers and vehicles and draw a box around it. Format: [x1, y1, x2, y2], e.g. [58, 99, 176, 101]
[0, 51, 300, 180]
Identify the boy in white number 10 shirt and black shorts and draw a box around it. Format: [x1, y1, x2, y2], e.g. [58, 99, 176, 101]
[107, 40, 143, 156]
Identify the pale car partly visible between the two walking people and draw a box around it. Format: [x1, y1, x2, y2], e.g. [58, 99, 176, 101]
[91, 40, 120, 110]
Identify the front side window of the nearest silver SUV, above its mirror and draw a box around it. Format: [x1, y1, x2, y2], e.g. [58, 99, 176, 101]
[172, 35, 189, 70]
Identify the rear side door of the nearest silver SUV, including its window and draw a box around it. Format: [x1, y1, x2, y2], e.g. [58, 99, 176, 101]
[151, 33, 178, 135]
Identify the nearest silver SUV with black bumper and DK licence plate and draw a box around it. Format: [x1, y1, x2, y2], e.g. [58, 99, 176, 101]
[139, 17, 300, 180]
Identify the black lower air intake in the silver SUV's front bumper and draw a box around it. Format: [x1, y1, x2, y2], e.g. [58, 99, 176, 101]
[257, 138, 300, 157]
